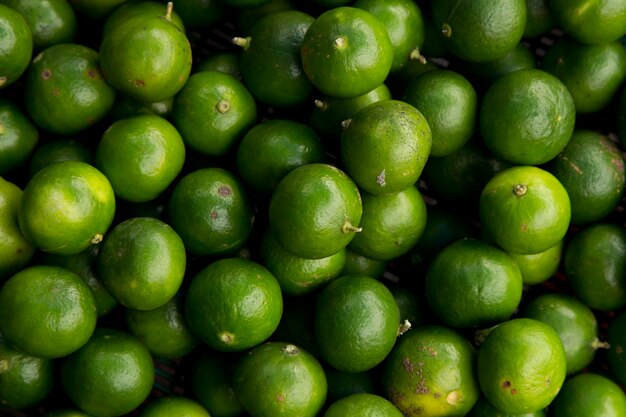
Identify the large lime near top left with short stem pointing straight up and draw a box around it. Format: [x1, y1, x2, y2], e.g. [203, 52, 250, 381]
[100, 10, 192, 103]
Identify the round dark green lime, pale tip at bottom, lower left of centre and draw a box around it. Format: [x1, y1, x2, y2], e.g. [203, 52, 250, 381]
[185, 258, 283, 351]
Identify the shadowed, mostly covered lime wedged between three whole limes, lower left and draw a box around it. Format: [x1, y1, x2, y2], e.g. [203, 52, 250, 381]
[124, 295, 198, 359]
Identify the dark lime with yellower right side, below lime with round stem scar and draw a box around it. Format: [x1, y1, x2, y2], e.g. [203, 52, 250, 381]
[426, 239, 523, 328]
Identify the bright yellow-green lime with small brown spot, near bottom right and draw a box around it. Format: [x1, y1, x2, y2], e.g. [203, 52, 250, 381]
[477, 318, 567, 414]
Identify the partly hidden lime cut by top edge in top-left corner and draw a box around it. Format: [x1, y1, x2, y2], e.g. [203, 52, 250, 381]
[0, 0, 78, 51]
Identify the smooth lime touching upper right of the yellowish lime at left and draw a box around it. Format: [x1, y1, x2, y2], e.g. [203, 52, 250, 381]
[95, 115, 185, 202]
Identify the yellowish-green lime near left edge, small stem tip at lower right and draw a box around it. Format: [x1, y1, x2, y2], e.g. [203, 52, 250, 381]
[19, 161, 115, 255]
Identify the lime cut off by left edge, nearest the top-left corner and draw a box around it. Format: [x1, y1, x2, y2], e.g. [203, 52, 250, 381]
[0, 4, 33, 90]
